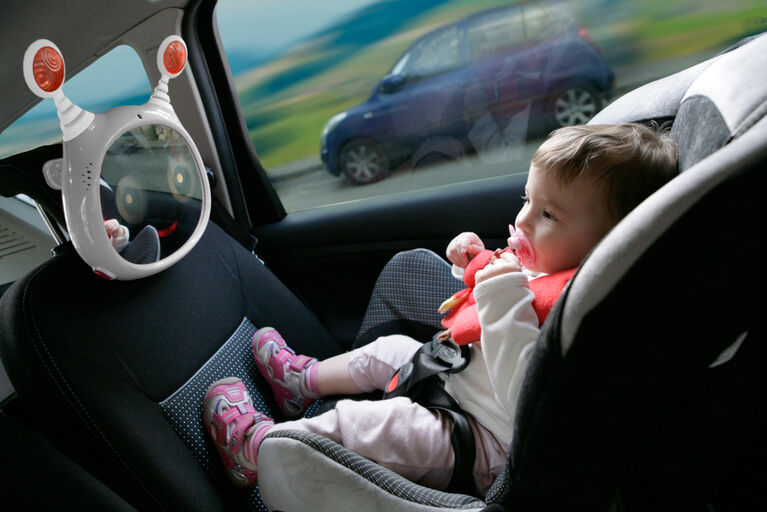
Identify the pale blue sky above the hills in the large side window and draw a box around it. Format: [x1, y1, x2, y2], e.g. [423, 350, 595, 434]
[216, 0, 381, 51]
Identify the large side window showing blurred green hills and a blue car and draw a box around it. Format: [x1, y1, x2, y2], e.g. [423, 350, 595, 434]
[217, 0, 767, 212]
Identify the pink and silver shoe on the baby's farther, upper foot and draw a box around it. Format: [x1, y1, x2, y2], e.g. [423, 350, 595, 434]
[251, 327, 320, 419]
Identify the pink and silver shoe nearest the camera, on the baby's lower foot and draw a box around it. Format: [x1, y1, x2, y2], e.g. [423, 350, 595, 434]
[202, 377, 274, 487]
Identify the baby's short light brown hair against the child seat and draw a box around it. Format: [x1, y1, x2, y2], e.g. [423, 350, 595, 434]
[532, 123, 677, 222]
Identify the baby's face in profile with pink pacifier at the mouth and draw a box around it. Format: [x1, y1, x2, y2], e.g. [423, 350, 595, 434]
[516, 166, 613, 274]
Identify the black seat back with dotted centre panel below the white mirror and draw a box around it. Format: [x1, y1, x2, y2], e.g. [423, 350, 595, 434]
[0, 147, 342, 510]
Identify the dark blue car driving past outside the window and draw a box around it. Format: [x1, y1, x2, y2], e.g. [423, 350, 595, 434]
[321, 3, 615, 184]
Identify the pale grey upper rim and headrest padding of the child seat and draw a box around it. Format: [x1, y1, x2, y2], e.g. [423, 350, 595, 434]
[561, 35, 767, 354]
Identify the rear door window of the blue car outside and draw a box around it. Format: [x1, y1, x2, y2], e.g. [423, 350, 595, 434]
[467, 7, 527, 59]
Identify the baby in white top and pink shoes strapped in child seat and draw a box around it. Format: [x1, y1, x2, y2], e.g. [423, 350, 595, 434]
[203, 124, 676, 494]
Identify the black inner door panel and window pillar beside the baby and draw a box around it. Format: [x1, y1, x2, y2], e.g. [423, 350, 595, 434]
[188, 0, 527, 346]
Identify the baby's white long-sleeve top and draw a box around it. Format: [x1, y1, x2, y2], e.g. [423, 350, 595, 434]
[443, 272, 540, 444]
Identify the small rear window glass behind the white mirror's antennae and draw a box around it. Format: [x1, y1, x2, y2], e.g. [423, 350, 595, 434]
[0, 46, 152, 158]
